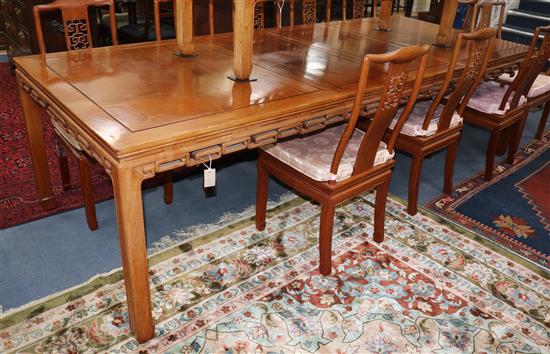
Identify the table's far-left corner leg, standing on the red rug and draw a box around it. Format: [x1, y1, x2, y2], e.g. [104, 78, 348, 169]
[18, 82, 57, 210]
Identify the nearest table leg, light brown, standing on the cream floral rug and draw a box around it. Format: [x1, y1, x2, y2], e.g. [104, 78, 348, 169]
[111, 168, 155, 343]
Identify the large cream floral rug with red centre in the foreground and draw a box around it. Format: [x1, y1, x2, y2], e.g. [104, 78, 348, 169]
[0, 194, 550, 353]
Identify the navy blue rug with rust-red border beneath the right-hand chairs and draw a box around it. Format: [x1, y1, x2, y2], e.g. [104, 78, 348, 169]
[427, 133, 550, 269]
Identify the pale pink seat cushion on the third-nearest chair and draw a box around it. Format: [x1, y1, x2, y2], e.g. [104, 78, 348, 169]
[468, 81, 527, 115]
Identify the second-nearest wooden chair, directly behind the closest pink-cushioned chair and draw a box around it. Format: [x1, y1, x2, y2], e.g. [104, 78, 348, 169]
[386, 28, 496, 215]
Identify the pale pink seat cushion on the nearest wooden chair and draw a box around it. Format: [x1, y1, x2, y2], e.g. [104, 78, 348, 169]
[263, 124, 394, 181]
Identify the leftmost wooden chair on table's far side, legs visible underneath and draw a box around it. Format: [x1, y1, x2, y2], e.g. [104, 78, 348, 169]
[33, 0, 172, 230]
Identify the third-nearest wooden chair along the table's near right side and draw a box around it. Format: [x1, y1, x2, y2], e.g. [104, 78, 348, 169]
[464, 26, 550, 181]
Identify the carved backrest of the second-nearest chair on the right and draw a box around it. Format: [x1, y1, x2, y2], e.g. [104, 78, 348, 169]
[422, 28, 496, 132]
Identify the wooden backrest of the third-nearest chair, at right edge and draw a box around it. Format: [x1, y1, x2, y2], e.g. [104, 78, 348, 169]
[500, 25, 550, 109]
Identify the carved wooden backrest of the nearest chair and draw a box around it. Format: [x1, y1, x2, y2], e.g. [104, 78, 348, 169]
[330, 44, 430, 175]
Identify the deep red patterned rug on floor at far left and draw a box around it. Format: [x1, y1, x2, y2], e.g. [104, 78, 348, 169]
[0, 63, 112, 229]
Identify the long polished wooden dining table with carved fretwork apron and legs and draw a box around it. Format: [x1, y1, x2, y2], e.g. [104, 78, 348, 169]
[15, 16, 527, 342]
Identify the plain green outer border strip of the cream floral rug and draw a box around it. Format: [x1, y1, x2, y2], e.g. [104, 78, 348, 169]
[0, 195, 550, 330]
